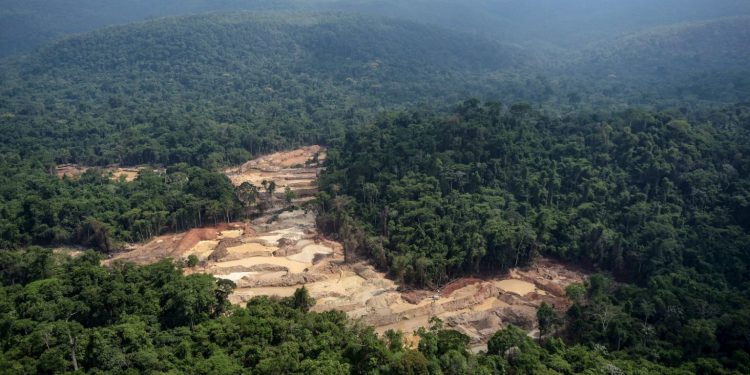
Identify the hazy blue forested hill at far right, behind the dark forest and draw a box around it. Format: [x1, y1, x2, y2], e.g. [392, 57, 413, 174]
[568, 17, 750, 105]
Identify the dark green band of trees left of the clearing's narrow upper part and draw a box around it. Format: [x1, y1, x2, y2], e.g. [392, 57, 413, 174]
[0, 156, 241, 252]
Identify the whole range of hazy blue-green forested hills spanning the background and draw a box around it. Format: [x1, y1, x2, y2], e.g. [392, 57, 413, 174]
[0, 13, 750, 166]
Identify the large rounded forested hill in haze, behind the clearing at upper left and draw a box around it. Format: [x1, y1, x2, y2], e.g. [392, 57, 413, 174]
[0, 13, 530, 167]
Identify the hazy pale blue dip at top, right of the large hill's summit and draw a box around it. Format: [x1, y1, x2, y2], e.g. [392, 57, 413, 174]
[326, 0, 750, 50]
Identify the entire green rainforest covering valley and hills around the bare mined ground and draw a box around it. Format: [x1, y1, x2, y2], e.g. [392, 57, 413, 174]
[0, 7, 750, 374]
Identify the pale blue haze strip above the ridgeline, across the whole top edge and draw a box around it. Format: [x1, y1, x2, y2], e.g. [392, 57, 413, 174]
[0, 0, 750, 56]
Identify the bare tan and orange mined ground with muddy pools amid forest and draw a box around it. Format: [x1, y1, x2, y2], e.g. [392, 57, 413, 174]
[110, 146, 584, 345]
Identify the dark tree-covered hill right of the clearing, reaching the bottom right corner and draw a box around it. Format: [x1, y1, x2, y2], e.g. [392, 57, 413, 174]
[320, 101, 750, 369]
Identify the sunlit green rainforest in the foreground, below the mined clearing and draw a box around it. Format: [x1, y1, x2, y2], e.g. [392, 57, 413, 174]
[0, 248, 728, 375]
